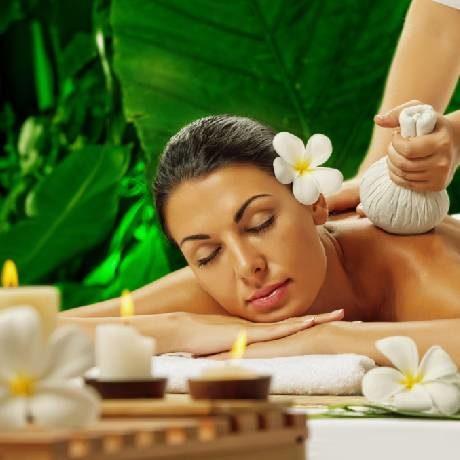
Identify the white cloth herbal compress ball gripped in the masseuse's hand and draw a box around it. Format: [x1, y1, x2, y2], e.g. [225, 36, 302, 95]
[360, 105, 449, 234]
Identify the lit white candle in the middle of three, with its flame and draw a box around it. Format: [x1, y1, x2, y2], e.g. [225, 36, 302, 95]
[95, 291, 155, 380]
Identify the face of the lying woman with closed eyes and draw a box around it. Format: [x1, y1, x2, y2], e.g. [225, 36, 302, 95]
[165, 165, 326, 322]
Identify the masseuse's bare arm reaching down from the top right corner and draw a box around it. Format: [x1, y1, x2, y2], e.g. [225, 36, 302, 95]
[358, 0, 460, 175]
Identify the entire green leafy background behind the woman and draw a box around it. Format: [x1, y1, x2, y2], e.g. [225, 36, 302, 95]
[0, 0, 460, 307]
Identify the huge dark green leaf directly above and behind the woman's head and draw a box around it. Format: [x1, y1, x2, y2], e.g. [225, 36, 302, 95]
[111, 0, 408, 173]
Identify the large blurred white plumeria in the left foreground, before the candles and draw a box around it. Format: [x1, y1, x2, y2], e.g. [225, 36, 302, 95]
[0, 306, 100, 428]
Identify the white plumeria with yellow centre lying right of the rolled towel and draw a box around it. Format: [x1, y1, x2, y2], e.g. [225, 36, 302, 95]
[362, 336, 460, 415]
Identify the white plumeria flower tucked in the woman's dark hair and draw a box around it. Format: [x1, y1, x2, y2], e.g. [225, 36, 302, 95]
[273, 132, 343, 205]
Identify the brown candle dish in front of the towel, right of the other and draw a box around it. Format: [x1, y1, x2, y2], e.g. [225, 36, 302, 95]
[188, 375, 271, 399]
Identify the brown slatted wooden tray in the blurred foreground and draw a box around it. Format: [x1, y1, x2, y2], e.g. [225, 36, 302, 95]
[0, 400, 307, 460]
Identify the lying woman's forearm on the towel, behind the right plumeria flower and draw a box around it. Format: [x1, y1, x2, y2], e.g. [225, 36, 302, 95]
[239, 319, 460, 367]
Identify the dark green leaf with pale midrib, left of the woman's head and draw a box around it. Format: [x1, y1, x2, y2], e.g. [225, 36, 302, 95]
[0, 146, 129, 283]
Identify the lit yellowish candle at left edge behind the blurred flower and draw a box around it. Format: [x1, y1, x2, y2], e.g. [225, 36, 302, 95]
[0, 260, 60, 337]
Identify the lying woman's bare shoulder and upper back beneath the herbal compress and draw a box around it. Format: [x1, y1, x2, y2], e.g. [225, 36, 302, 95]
[327, 217, 460, 321]
